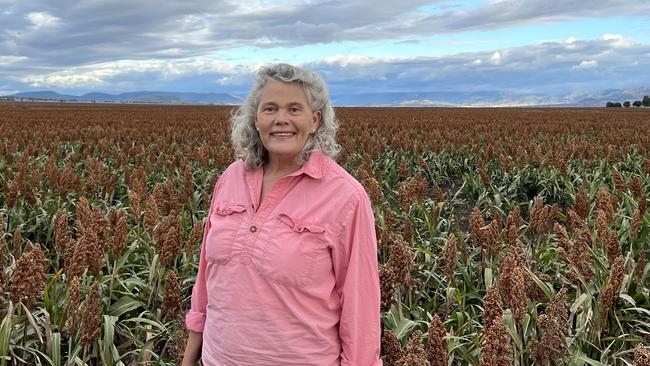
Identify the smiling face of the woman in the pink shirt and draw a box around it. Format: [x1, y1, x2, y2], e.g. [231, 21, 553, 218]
[255, 80, 321, 167]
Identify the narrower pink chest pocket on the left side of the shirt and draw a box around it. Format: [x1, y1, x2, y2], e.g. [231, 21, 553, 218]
[206, 202, 246, 263]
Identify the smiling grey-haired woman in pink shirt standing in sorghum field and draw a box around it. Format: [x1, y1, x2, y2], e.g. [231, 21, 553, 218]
[183, 64, 382, 366]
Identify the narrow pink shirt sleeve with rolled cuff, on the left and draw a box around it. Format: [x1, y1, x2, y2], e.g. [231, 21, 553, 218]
[185, 181, 219, 333]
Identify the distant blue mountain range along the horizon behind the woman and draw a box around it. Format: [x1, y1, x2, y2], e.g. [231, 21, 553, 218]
[4, 87, 650, 107]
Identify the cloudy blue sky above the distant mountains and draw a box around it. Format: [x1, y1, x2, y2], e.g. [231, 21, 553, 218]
[0, 0, 650, 95]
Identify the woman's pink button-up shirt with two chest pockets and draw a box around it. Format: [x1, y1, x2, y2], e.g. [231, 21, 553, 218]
[186, 151, 382, 366]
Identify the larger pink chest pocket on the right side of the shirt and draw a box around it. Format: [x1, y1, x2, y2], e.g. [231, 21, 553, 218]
[256, 214, 329, 288]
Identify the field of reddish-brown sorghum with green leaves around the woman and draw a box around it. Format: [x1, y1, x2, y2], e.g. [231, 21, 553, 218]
[0, 103, 650, 366]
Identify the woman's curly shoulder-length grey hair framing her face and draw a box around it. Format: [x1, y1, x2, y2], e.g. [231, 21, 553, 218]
[230, 63, 341, 169]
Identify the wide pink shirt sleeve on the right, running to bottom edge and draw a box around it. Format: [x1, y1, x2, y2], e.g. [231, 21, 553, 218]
[332, 192, 382, 366]
